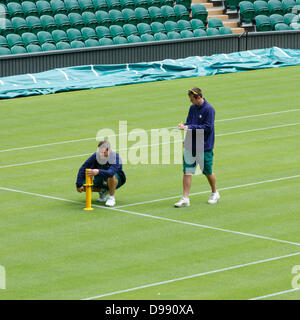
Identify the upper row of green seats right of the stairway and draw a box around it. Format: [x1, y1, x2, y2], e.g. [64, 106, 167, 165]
[239, 0, 300, 23]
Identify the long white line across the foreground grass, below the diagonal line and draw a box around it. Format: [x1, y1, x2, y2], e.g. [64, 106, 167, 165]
[81, 252, 300, 300]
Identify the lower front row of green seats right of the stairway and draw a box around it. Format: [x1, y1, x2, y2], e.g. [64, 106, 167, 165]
[255, 13, 300, 31]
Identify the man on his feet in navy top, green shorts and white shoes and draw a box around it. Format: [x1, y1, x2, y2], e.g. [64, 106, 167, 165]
[175, 88, 220, 208]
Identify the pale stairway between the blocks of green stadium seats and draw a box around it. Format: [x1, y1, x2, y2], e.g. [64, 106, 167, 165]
[192, 0, 245, 34]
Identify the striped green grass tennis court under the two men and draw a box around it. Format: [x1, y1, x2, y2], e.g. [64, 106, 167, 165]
[0, 67, 300, 299]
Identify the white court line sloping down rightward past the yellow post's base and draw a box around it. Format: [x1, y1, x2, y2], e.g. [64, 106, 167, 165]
[0, 175, 300, 246]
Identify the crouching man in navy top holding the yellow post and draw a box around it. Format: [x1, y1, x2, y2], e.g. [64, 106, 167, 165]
[76, 141, 126, 207]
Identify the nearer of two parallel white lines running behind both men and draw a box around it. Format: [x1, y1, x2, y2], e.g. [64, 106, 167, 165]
[0, 122, 300, 169]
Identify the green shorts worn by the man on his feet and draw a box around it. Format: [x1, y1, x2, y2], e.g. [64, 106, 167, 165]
[183, 150, 214, 175]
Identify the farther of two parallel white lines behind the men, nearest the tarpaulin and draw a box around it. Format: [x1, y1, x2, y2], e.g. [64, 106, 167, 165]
[0, 107, 300, 152]
